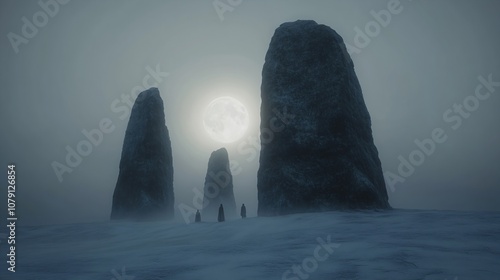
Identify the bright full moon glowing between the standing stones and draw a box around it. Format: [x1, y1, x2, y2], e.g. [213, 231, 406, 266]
[203, 96, 249, 143]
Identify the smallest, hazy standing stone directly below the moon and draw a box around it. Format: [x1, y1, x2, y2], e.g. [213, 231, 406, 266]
[203, 148, 236, 221]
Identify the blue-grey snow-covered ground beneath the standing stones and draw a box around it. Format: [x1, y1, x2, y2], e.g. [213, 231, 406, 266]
[0, 210, 500, 280]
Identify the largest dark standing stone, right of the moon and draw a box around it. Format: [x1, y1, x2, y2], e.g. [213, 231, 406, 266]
[257, 21, 390, 216]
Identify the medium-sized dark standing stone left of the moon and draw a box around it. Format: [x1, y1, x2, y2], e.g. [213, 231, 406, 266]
[111, 88, 174, 219]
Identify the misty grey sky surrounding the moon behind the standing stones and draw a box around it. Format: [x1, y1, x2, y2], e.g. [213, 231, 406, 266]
[0, 0, 500, 225]
